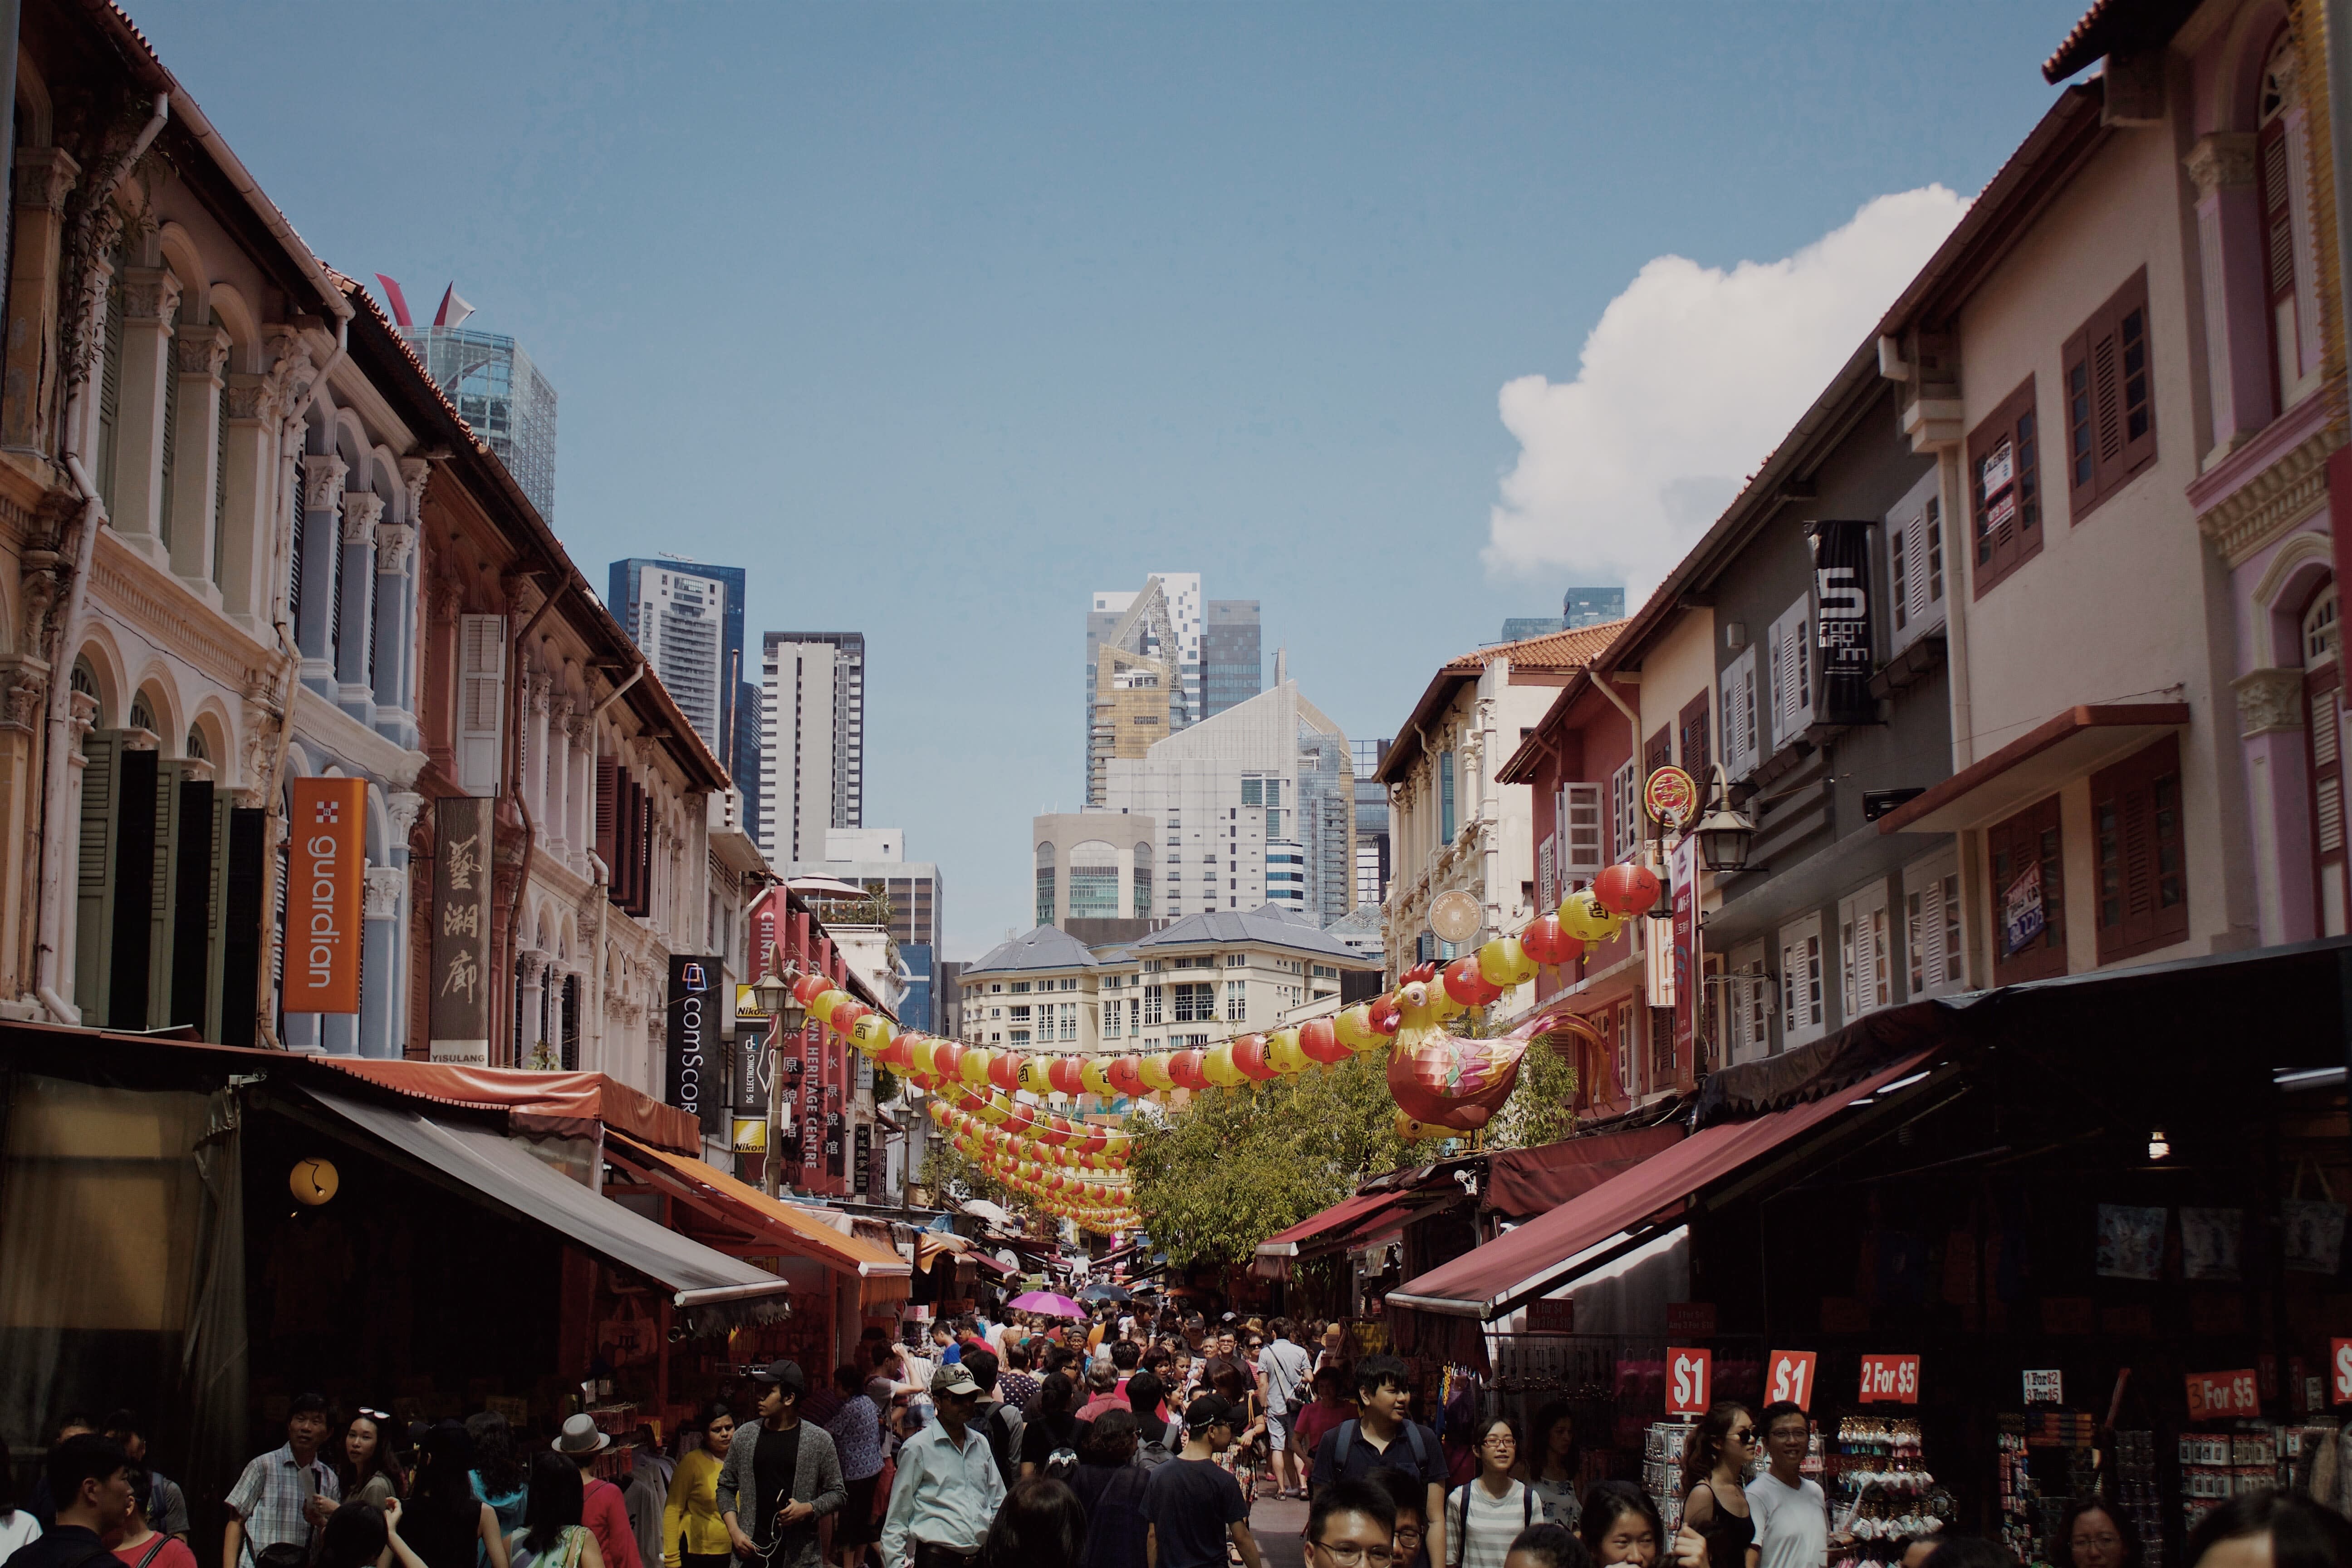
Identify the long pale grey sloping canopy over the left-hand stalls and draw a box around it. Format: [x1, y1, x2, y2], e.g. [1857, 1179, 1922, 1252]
[304, 1088, 788, 1317]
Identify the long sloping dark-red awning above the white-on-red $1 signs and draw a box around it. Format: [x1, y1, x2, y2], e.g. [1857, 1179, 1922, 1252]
[1388, 1051, 1929, 1321]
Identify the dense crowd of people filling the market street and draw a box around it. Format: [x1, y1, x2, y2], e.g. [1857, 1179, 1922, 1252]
[14, 1312, 2352, 1568]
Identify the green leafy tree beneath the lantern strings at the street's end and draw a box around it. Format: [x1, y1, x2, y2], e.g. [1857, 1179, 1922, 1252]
[1127, 1051, 1406, 1262]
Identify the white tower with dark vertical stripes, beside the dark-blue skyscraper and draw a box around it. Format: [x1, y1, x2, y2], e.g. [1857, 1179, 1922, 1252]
[760, 632, 866, 865]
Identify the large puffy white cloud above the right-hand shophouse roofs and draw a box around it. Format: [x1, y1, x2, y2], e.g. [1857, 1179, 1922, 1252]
[1486, 186, 1969, 609]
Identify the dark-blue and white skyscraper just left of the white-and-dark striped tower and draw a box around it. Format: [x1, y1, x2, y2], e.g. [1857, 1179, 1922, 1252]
[604, 555, 760, 839]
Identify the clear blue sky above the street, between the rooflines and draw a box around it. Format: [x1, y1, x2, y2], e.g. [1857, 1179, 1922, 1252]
[132, 0, 2082, 957]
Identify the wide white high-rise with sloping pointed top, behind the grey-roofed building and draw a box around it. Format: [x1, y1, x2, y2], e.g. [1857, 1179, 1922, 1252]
[1105, 670, 1355, 926]
